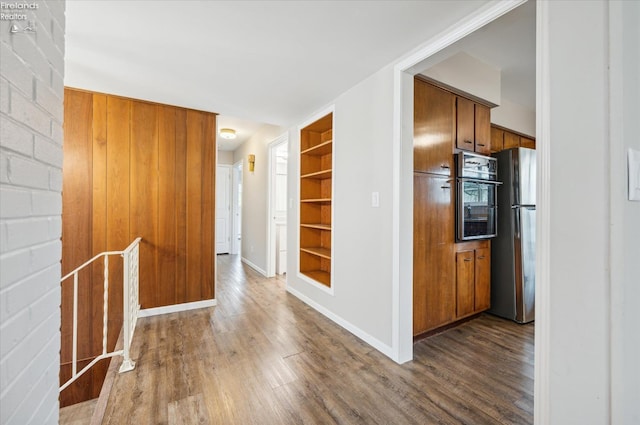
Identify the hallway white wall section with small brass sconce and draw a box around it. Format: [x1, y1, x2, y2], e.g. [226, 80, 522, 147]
[232, 124, 286, 274]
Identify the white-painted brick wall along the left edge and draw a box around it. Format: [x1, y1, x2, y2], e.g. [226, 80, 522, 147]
[0, 0, 65, 425]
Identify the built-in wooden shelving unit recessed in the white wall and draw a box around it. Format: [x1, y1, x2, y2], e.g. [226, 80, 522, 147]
[300, 113, 333, 288]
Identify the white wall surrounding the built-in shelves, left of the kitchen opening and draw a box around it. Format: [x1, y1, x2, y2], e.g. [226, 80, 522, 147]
[287, 66, 393, 354]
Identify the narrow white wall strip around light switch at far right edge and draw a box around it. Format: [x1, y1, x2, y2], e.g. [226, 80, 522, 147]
[609, 2, 640, 425]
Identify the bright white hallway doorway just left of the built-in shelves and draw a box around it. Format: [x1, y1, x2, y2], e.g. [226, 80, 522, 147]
[267, 133, 289, 277]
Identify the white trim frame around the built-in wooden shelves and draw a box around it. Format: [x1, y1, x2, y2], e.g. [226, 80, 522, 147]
[296, 104, 336, 296]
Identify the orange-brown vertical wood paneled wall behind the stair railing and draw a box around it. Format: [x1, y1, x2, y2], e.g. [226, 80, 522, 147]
[60, 88, 216, 406]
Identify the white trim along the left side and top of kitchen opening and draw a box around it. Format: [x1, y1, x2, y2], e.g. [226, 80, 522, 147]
[391, 0, 526, 363]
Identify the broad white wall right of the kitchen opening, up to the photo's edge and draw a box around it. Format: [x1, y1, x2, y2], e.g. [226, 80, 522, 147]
[536, 1, 640, 424]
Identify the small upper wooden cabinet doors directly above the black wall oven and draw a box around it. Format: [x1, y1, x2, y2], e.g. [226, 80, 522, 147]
[456, 96, 491, 154]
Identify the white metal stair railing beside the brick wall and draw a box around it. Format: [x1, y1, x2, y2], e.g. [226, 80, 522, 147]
[60, 238, 142, 392]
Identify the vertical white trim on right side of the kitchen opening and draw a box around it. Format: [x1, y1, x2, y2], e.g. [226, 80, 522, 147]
[533, 1, 551, 425]
